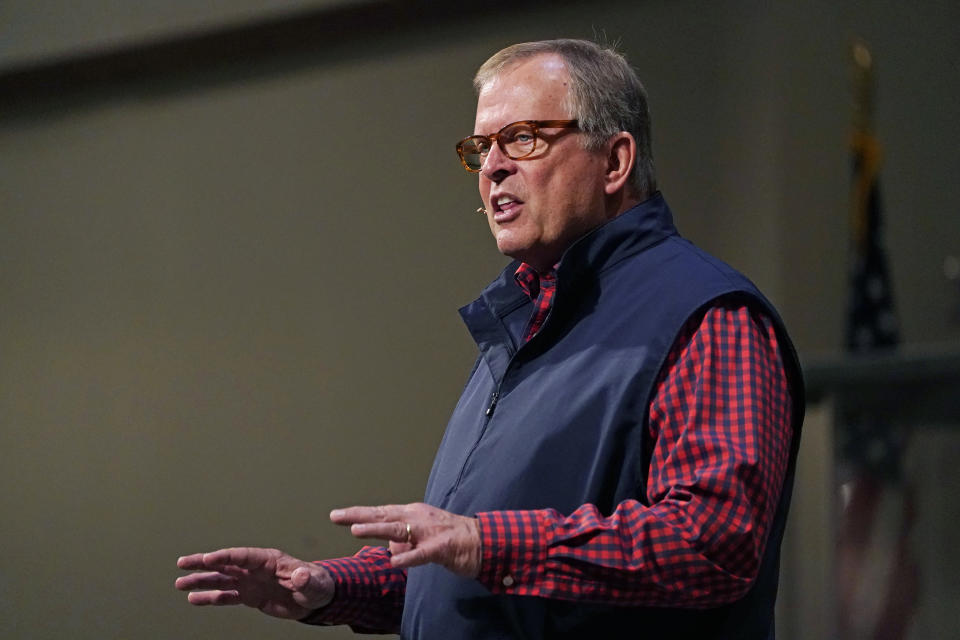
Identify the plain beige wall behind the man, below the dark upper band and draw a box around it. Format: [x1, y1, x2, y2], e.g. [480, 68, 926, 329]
[0, 1, 960, 638]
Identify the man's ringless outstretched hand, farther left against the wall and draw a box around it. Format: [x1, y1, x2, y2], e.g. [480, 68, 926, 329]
[176, 547, 334, 620]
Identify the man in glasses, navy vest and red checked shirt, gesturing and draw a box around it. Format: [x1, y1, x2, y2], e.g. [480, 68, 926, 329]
[177, 40, 803, 639]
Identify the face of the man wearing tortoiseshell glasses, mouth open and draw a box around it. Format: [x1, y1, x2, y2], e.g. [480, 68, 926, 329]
[474, 55, 607, 271]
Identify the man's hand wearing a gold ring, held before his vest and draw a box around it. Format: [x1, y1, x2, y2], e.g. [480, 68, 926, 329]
[330, 503, 481, 578]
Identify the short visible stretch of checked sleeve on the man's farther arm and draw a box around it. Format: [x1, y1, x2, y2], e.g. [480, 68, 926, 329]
[301, 547, 407, 633]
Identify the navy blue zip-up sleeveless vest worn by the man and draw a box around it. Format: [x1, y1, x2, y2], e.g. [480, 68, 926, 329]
[402, 194, 803, 640]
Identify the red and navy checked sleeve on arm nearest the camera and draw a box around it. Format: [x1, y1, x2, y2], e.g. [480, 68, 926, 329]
[477, 300, 792, 607]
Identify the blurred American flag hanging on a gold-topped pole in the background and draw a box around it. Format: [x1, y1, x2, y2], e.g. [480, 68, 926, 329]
[837, 42, 919, 640]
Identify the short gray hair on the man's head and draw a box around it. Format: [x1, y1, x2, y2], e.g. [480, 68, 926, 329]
[473, 39, 657, 195]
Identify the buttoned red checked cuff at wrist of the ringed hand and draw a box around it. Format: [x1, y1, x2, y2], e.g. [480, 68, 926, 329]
[477, 511, 549, 595]
